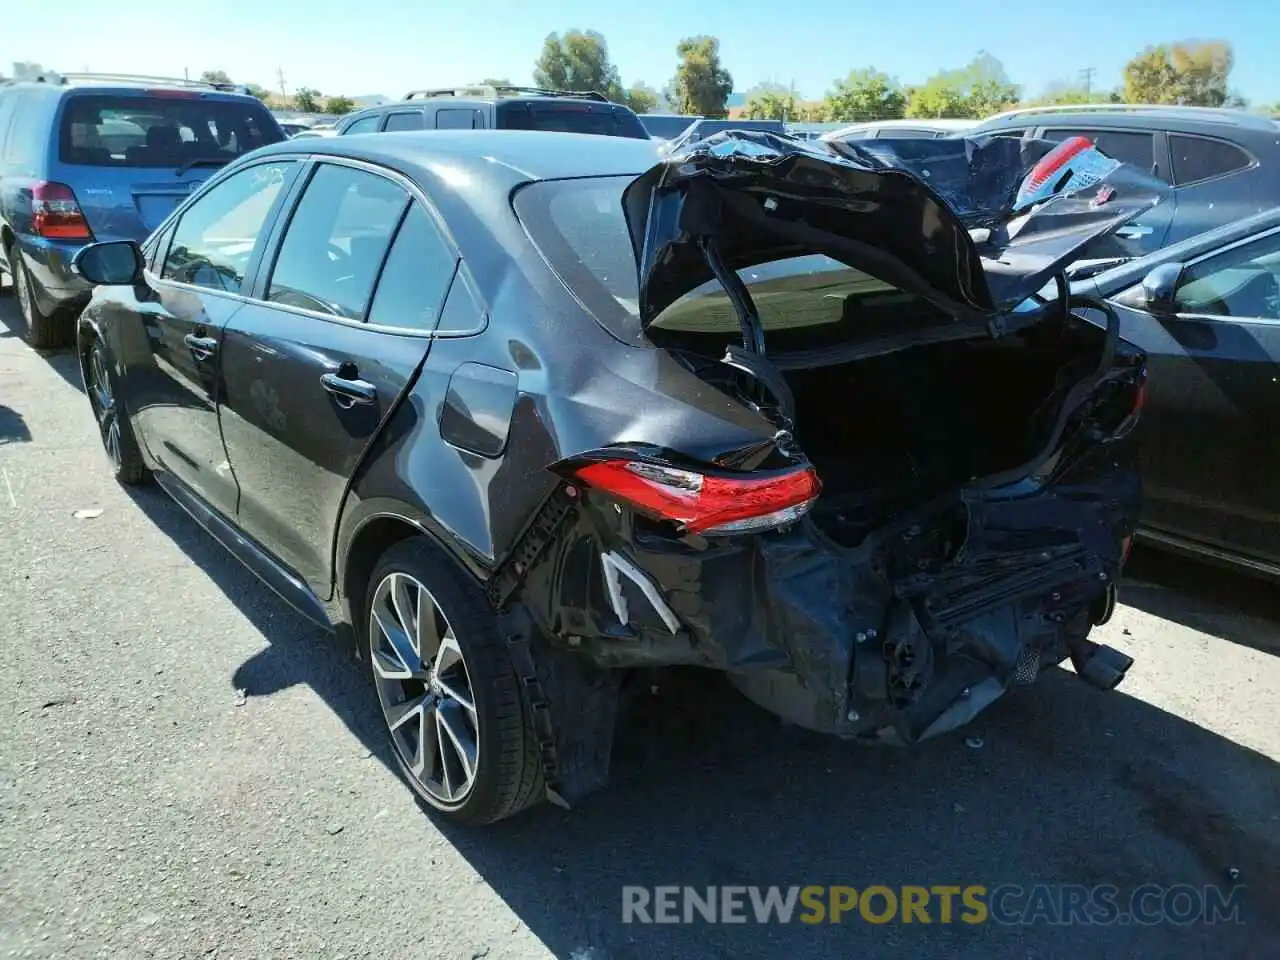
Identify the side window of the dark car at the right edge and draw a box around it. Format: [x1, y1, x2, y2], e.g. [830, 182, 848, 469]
[1175, 233, 1280, 320]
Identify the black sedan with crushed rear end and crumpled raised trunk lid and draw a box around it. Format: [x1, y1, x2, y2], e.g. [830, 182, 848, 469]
[77, 132, 1162, 822]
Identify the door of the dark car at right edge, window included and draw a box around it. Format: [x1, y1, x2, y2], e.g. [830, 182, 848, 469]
[1117, 230, 1280, 559]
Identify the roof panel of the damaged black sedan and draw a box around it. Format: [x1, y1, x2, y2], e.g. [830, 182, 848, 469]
[253, 131, 659, 189]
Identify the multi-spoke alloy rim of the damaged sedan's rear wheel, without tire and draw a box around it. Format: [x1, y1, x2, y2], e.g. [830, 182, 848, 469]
[369, 572, 480, 809]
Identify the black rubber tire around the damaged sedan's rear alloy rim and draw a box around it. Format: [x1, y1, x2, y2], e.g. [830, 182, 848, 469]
[356, 536, 544, 824]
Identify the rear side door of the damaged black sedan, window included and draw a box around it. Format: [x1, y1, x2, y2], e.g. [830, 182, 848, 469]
[220, 160, 457, 596]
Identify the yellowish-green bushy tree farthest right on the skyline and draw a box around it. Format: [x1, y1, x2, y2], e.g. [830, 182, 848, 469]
[1124, 40, 1235, 106]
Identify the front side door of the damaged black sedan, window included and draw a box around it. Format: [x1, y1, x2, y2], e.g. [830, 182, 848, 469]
[129, 160, 298, 516]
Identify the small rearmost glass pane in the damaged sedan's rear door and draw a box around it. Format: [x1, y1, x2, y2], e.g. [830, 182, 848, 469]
[369, 204, 457, 330]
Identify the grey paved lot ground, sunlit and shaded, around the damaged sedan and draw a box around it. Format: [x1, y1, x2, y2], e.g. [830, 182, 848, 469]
[0, 297, 1280, 960]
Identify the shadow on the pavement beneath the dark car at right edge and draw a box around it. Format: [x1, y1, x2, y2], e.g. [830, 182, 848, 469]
[1120, 547, 1280, 654]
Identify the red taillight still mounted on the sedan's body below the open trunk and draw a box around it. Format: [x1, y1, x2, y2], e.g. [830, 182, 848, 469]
[575, 460, 822, 535]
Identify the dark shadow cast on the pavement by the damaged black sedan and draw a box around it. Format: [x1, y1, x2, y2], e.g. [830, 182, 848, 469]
[122, 490, 1280, 960]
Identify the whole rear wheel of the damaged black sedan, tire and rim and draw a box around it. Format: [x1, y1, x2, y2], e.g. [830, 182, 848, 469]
[362, 538, 541, 823]
